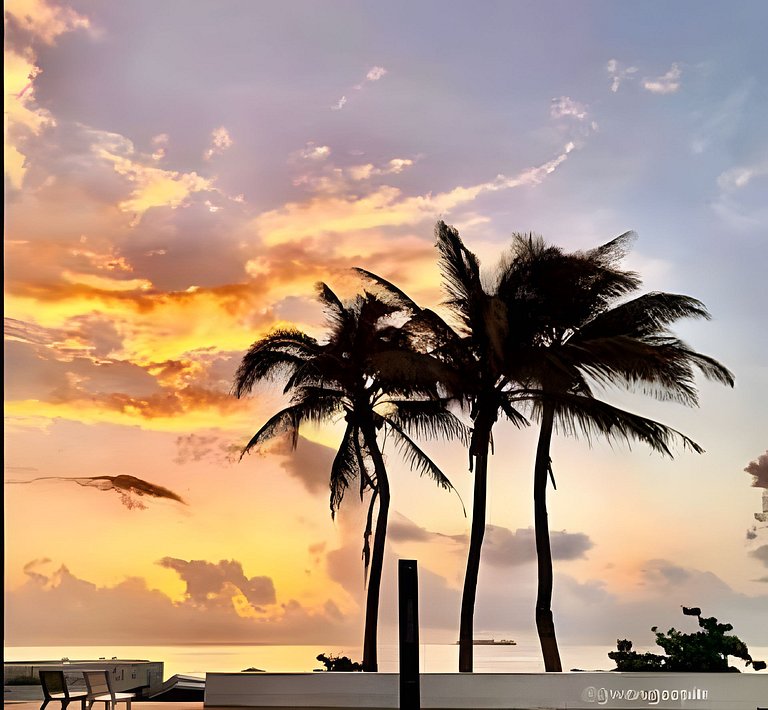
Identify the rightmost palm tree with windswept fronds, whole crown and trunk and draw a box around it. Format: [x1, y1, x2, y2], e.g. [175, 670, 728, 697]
[499, 233, 733, 671]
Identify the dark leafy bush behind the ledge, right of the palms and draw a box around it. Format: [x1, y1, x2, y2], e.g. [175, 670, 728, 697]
[608, 607, 765, 673]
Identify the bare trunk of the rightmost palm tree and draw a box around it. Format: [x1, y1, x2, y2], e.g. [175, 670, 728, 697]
[533, 401, 563, 672]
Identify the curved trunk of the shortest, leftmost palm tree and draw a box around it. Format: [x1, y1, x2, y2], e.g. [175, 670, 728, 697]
[361, 422, 390, 673]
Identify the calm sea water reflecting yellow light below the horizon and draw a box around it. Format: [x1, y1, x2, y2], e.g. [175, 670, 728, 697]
[4, 641, 768, 679]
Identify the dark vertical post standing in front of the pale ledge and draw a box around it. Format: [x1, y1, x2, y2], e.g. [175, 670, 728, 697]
[397, 560, 421, 710]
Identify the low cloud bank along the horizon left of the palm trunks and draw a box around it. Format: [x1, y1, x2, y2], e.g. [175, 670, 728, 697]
[5, 557, 361, 646]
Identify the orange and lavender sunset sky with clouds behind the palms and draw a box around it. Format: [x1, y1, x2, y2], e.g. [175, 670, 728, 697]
[4, 0, 768, 663]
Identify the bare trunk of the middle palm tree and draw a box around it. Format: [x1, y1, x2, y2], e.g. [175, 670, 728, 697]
[459, 434, 489, 673]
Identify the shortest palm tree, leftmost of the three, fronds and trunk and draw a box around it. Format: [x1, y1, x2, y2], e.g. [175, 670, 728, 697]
[233, 284, 465, 671]
